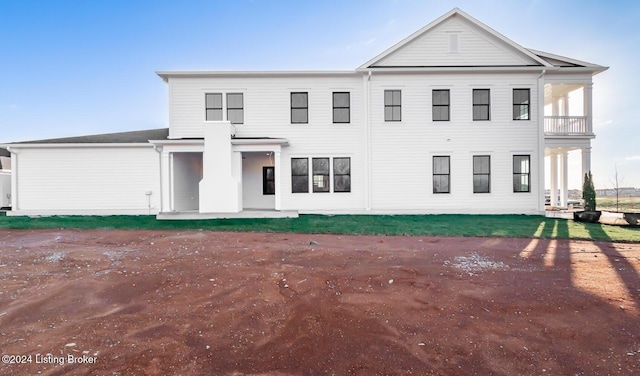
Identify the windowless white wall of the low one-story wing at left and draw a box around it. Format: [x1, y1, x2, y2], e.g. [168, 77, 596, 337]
[9, 144, 160, 215]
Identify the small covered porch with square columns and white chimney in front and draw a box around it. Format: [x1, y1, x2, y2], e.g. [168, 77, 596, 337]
[150, 122, 290, 219]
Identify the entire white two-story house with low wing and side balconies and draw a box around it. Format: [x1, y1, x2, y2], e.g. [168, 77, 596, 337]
[2, 8, 607, 218]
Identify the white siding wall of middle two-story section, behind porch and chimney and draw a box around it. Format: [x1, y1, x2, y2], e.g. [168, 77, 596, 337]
[169, 73, 366, 211]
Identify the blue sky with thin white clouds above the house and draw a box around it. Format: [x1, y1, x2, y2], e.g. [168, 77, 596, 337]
[0, 0, 640, 188]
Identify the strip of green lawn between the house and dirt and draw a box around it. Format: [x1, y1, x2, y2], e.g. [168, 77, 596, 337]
[0, 214, 640, 242]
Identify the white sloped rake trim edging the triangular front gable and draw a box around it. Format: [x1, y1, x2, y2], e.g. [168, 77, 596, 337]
[358, 8, 552, 69]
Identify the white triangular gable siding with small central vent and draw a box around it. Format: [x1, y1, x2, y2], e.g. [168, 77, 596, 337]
[374, 16, 539, 67]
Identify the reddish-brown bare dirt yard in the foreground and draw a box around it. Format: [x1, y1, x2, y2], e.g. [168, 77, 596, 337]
[0, 230, 640, 375]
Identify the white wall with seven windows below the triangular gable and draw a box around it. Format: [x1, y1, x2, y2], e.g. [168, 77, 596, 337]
[371, 74, 544, 214]
